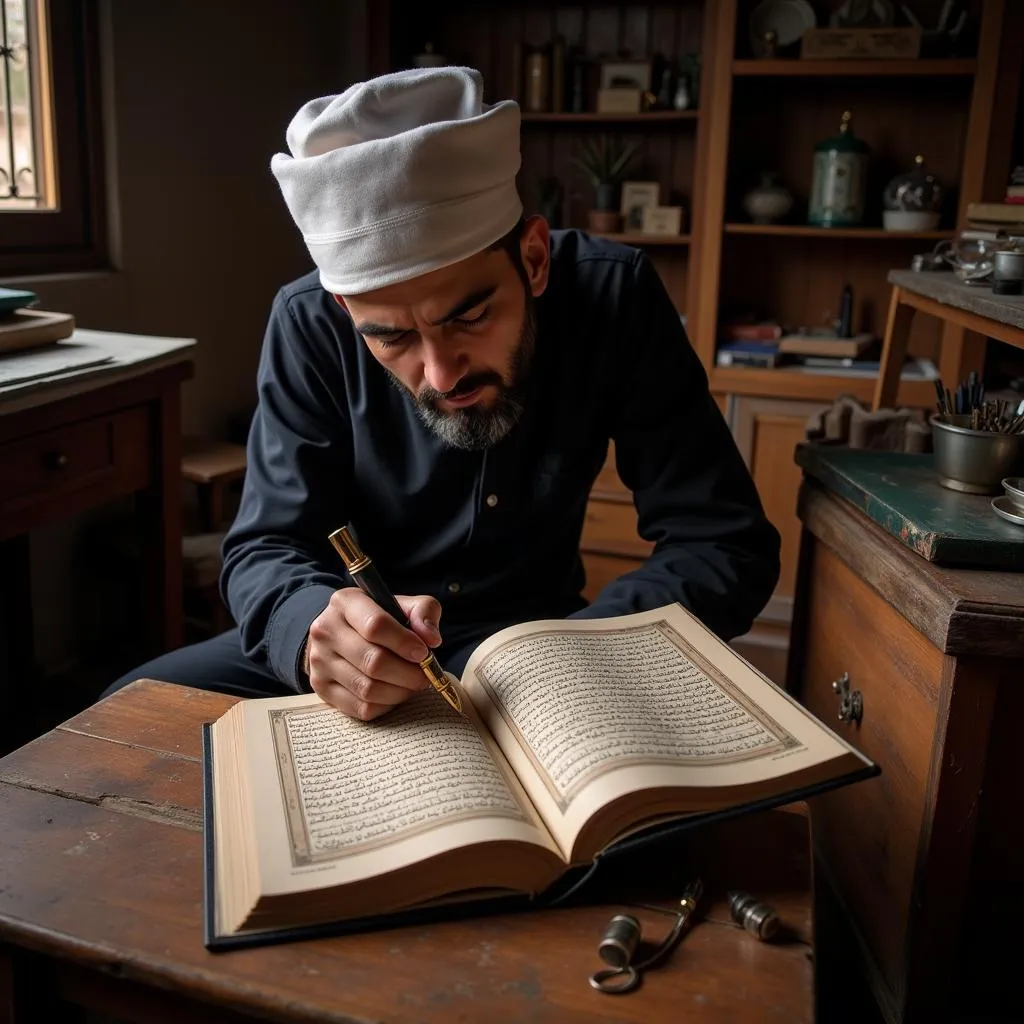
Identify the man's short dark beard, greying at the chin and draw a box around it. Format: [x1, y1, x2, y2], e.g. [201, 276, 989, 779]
[388, 292, 537, 452]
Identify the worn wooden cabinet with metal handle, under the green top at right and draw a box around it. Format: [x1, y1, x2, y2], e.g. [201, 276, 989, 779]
[787, 481, 1024, 1024]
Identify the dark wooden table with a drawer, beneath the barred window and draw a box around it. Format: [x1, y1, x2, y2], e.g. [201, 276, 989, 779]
[0, 331, 195, 752]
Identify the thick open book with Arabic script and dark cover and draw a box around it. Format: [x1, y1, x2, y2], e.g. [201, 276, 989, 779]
[207, 604, 878, 947]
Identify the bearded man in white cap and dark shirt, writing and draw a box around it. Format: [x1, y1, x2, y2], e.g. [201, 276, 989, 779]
[110, 68, 779, 719]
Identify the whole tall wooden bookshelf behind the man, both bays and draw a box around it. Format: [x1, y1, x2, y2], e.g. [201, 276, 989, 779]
[371, 0, 1024, 681]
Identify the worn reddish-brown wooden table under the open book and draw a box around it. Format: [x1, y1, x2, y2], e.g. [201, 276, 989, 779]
[0, 681, 813, 1024]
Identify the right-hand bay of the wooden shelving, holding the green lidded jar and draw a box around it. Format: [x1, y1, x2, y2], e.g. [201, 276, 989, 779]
[688, 0, 1024, 696]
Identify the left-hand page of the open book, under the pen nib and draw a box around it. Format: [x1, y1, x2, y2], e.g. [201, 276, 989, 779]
[236, 690, 556, 894]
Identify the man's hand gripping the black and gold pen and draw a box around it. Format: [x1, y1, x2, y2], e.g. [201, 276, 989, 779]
[304, 587, 441, 722]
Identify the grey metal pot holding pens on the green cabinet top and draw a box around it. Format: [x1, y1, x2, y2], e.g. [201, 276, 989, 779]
[930, 414, 1024, 495]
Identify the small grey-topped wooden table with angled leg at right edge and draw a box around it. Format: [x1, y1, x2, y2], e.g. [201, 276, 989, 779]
[871, 270, 1024, 410]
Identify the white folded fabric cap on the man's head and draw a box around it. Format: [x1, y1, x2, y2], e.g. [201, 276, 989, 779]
[270, 68, 522, 295]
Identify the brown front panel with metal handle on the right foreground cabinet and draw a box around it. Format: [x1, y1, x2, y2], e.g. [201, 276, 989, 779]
[801, 547, 942, 993]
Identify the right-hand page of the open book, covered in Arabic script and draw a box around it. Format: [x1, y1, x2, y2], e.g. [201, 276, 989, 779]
[463, 605, 864, 850]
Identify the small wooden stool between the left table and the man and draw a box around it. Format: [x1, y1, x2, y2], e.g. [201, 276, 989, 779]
[181, 437, 246, 635]
